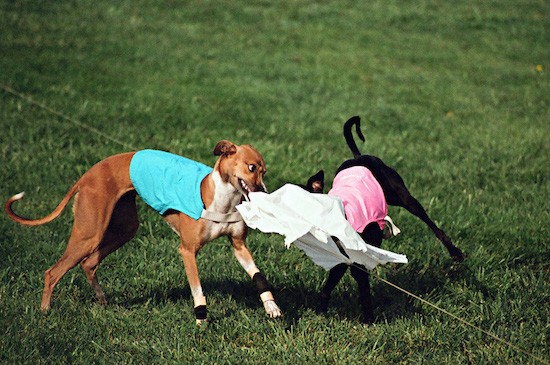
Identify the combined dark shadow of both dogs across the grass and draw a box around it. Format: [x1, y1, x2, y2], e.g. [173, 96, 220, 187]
[111, 262, 496, 326]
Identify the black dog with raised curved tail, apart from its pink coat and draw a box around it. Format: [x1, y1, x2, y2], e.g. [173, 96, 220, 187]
[302, 117, 464, 323]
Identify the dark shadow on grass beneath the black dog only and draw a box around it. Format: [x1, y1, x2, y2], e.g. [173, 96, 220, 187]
[284, 260, 497, 323]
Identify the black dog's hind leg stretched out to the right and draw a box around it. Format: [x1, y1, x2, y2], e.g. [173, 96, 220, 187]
[379, 166, 464, 262]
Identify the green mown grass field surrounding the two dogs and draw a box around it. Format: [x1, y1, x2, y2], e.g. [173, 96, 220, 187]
[0, 0, 550, 364]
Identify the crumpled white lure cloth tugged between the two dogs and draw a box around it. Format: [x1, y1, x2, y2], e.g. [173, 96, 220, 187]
[237, 184, 408, 270]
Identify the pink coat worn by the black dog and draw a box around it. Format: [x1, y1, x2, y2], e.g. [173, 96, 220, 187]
[328, 166, 388, 233]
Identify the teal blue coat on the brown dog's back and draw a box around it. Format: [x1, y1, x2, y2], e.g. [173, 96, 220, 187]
[130, 150, 212, 220]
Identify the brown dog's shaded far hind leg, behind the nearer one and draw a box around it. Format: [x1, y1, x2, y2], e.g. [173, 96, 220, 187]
[80, 191, 139, 304]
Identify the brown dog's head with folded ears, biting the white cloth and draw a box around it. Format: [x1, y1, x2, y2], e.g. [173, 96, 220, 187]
[214, 140, 266, 196]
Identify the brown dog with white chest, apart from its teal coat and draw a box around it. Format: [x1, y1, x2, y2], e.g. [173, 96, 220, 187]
[5, 140, 281, 324]
